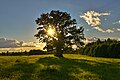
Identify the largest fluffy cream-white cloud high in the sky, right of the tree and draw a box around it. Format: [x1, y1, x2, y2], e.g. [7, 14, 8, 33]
[80, 11, 110, 26]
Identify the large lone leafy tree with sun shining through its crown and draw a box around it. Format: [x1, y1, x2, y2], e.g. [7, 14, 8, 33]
[35, 10, 84, 57]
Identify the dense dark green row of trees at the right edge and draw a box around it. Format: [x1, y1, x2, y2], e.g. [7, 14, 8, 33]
[79, 38, 120, 58]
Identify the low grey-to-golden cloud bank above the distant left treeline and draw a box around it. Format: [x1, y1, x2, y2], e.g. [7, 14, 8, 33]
[0, 38, 45, 49]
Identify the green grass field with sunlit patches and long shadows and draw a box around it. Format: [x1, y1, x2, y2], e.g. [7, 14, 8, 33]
[0, 54, 120, 80]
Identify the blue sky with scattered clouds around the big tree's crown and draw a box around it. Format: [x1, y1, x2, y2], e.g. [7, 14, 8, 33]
[0, 0, 120, 41]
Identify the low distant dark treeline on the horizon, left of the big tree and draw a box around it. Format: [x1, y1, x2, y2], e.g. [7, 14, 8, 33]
[0, 50, 47, 56]
